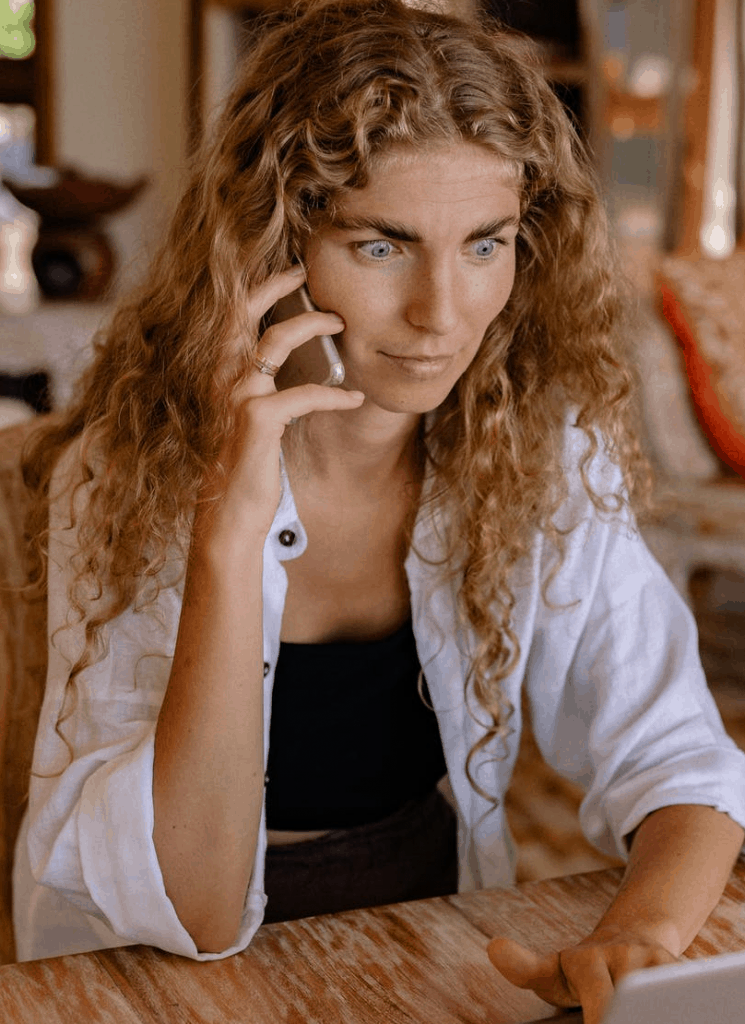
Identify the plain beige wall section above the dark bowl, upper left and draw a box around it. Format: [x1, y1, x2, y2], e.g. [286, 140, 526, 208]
[48, 0, 189, 285]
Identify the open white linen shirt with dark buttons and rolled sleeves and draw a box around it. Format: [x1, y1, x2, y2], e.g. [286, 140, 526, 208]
[13, 426, 745, 959]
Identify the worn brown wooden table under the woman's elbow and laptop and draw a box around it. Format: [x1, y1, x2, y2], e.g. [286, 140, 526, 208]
[0, 860, 745, 1024]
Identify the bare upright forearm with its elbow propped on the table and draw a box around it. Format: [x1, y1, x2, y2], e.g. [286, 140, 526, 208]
[154, 528, 264, 951]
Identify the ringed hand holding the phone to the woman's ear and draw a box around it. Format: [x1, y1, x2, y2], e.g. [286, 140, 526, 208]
[198, 268, 364, 543]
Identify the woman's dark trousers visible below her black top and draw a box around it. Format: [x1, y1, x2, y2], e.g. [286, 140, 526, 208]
[264, 790, 457, 923]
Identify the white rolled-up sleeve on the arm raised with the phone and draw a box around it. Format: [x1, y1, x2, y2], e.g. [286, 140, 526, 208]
[20, 444, 266, 959]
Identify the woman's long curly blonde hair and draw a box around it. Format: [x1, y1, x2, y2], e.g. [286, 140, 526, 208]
[27, 0, 643, 792]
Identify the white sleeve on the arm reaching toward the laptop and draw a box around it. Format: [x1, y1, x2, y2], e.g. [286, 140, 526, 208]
[529, 432, 745, 858]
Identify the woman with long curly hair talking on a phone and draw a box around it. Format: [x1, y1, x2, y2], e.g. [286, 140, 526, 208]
[16, 0, 745, 1022]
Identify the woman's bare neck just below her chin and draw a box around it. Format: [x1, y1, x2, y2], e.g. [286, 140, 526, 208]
[287, 404, 423, 489]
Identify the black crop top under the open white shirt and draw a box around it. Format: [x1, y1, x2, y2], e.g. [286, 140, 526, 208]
[266, 622, 446, 830]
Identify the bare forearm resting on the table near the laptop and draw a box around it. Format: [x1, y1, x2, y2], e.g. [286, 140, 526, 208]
[594, 804, 745, 956]
